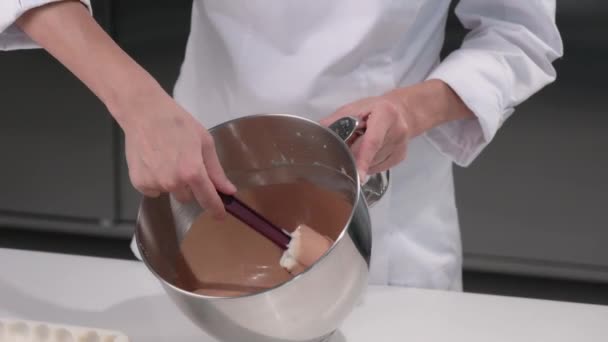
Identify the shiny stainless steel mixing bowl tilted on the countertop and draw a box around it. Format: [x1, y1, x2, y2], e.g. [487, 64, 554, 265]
[135, 114, 388, 342]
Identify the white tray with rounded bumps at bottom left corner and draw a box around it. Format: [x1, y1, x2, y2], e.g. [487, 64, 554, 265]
[0, 318, 129, 342]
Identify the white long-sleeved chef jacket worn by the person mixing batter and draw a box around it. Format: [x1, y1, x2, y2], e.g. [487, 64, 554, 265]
[0, 0, 563, 290]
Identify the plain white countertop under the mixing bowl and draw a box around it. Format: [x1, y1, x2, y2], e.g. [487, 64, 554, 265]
[0, 248, 608, 342]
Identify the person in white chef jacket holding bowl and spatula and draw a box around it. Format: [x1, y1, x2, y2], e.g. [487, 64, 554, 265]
[0, 0, 563, 291]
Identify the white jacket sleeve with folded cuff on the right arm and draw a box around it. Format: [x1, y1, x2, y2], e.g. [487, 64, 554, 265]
[425, 0, 563, 166]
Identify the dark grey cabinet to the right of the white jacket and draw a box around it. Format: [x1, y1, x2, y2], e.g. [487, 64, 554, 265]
[448, 0, 608, 281]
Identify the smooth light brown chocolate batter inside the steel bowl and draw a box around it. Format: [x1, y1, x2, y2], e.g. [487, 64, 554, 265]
[176, 180, 353, 297]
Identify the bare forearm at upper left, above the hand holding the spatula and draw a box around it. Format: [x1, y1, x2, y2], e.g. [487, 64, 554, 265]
[17, 1, 161, 125]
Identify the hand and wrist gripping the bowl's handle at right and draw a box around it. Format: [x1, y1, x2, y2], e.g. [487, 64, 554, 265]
[320, 80, 473, 180]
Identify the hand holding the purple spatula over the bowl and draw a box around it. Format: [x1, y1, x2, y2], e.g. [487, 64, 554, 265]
[117, 87, 236, 218]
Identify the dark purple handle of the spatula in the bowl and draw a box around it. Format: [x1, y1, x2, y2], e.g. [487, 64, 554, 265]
[219, 193, 291, 250]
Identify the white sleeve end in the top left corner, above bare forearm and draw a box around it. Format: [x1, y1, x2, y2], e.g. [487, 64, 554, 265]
[0, 0, 93, 51]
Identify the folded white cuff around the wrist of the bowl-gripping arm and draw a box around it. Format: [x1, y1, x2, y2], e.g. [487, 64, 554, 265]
[424, 51, 513, 166]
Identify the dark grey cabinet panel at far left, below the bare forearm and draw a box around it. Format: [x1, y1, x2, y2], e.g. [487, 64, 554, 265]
[0, 49, 114, 219]
